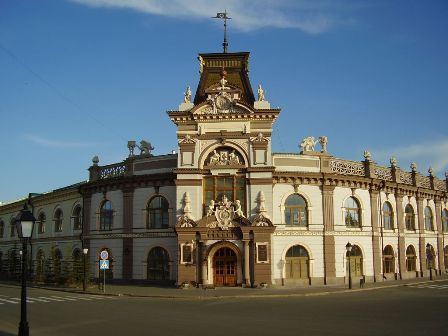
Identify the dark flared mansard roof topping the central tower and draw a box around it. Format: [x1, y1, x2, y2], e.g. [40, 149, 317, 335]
[194, 52, 255, 106]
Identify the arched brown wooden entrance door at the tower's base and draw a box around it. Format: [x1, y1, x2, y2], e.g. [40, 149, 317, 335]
[213, 247, 237, 286]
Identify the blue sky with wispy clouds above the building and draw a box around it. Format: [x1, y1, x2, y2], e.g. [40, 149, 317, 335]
[0, 0, 448, 202]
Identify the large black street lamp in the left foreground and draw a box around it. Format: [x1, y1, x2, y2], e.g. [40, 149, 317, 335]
[15, 204, 36, 336]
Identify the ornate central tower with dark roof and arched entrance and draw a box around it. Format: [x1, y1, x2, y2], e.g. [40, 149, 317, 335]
[168, 52, 280, 285]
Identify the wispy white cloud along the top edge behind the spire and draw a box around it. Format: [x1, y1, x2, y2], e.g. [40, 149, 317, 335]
[71, 0, 359, 34]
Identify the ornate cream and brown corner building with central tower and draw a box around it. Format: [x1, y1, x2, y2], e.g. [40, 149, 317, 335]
[0, 48, 448, 286]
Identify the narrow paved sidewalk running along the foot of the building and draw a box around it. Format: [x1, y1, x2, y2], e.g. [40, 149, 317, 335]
[13, 275, 448, 299]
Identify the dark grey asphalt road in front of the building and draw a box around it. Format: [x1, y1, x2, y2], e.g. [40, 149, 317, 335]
[0, 281, 448, 336]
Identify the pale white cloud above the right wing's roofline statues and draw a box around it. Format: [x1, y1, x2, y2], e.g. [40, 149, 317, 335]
[372, 139, 448, 175]
